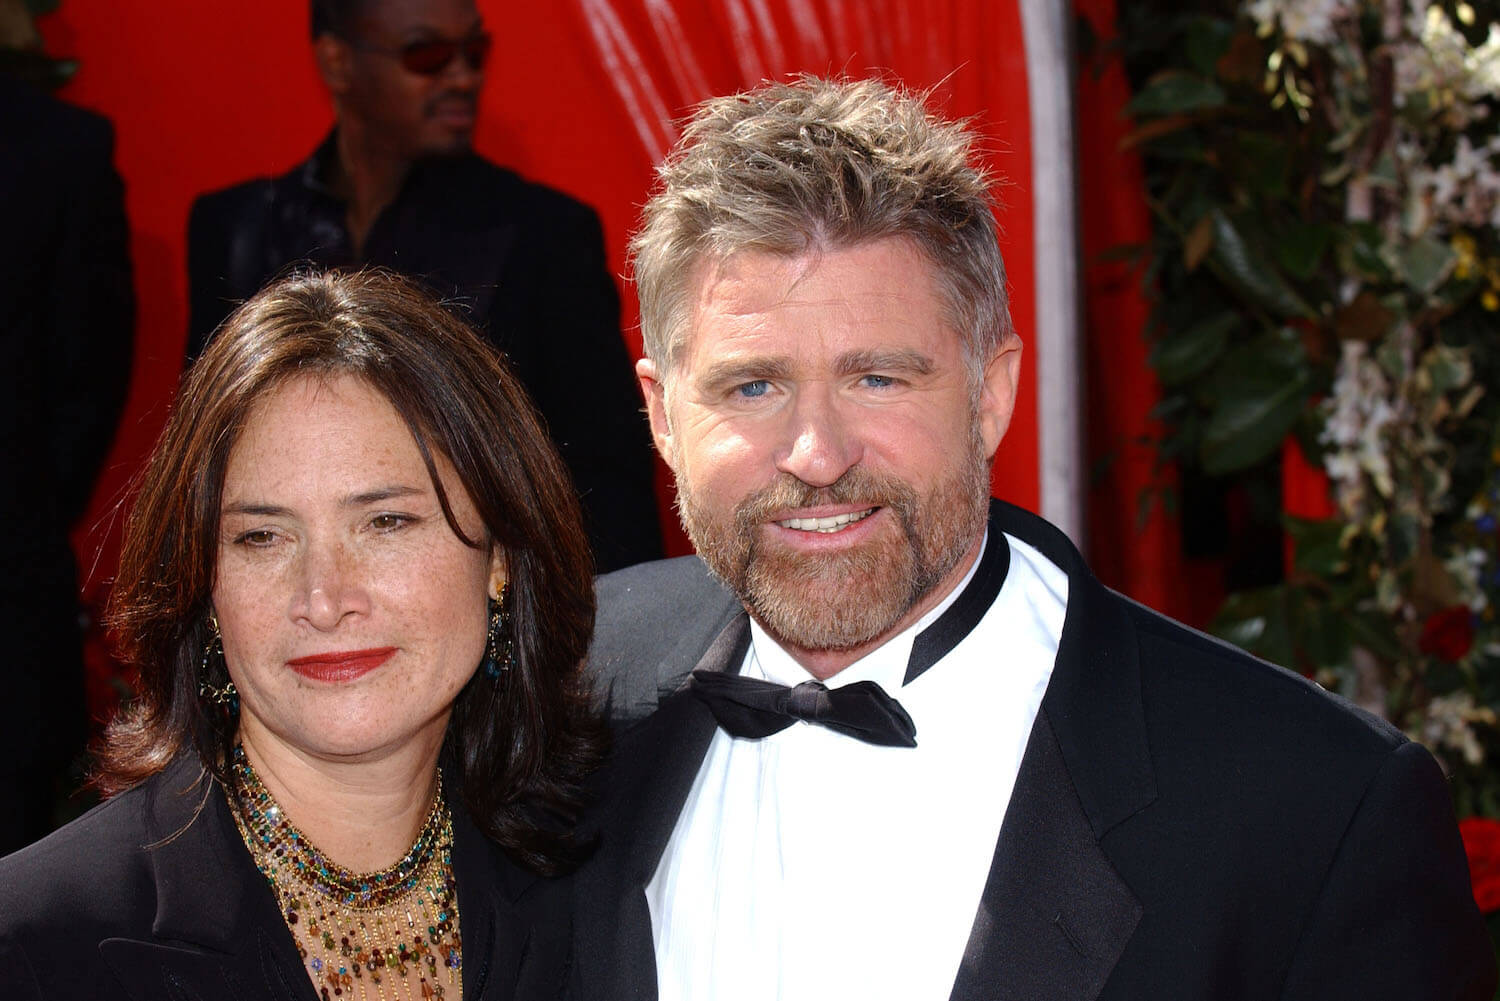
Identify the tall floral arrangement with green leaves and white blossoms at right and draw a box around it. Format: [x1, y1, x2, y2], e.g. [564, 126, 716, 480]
[1121, 0, 1500, 870]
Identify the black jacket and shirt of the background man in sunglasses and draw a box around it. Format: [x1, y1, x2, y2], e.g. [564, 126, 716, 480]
[188, 135, 662, 570]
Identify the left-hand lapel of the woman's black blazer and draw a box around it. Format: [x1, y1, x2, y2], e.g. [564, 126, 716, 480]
[99, 755, 314, 1001]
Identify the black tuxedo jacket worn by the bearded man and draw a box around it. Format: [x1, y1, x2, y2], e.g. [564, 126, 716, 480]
[570, 503, 1496, 1001]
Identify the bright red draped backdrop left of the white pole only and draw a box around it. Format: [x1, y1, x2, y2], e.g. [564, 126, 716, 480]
[41, 0, 1038, 606]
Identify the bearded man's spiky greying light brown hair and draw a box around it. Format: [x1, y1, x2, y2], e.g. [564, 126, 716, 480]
[630, 77, 1013, 377]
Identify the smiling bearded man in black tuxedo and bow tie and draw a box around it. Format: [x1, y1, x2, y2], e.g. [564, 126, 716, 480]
[573, 78, 1496, 1001]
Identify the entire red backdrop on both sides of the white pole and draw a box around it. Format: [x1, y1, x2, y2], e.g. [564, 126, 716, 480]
[41, 0, 1214, 720]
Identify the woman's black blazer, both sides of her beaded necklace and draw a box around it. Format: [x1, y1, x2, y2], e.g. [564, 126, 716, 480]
[0, 755, 569, 1001]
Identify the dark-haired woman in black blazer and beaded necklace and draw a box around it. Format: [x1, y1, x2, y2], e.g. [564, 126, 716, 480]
[0, 272, 599, 1001]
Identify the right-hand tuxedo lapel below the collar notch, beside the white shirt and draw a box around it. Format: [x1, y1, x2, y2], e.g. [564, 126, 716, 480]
[953, 710, 1140, 1001]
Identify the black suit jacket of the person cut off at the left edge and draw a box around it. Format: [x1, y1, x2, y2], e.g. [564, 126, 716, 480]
[0, 75, 135, 854]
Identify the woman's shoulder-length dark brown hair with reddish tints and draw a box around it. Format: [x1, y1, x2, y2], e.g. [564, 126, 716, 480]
[96, 270, 603, 873]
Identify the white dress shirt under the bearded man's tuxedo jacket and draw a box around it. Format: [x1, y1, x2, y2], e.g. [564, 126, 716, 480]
[647, 536, 1068, 1001]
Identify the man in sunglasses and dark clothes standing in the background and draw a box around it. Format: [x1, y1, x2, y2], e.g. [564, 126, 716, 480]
[188, 0, 662, 570]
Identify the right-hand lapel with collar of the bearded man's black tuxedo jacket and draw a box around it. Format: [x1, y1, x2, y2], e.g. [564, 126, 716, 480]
[953, 501, 1157, 1001]
